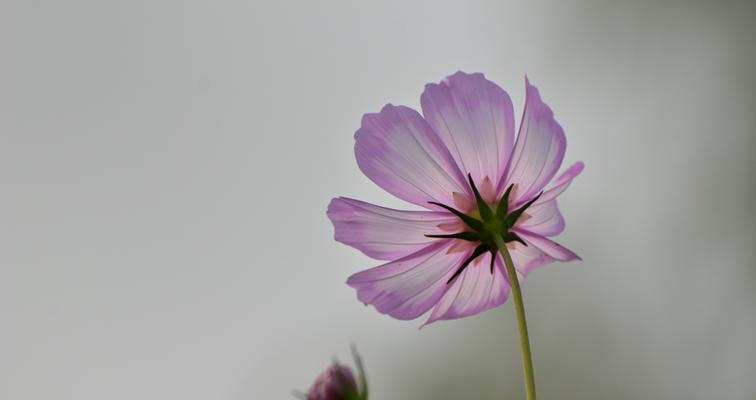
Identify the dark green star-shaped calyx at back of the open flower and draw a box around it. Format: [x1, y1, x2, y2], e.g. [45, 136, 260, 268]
[425, 174, 543, 284]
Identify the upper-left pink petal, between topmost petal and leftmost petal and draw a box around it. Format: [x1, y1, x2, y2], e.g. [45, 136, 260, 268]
[354, 104, 467, 207]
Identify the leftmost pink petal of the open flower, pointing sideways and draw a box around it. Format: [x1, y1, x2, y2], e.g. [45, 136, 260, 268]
[327, 197, 458, 260]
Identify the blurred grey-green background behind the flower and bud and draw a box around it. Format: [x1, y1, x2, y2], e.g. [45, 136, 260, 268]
[0, 0, 756, 400]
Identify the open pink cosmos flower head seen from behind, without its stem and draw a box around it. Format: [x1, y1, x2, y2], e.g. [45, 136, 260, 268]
[327, 72, 583, 324]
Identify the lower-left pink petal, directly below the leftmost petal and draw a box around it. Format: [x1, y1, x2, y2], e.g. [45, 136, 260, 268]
[347, 240, 468, 320]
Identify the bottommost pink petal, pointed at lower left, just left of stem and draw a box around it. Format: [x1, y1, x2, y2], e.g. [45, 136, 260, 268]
[423, 253, 509, 326]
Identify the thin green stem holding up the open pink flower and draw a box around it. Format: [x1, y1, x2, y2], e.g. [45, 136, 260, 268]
[494, 235, 535, 400]
